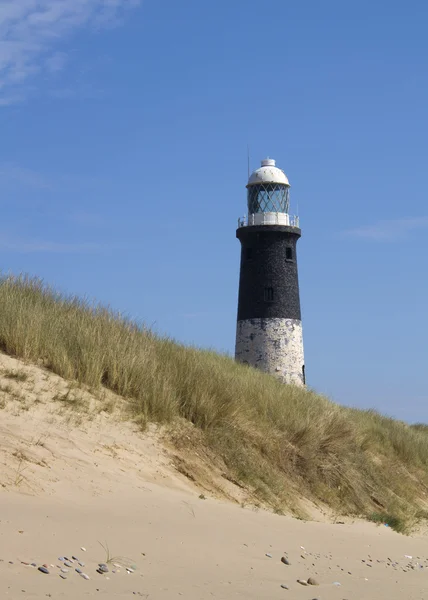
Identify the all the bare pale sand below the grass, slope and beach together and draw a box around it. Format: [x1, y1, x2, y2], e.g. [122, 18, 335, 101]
[0, 357, 428, 600]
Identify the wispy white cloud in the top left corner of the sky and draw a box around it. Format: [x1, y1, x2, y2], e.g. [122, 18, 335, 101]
[0, 0, 141, 106]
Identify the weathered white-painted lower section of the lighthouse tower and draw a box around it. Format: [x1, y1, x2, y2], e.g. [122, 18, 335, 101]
[235, 318, 305, 386]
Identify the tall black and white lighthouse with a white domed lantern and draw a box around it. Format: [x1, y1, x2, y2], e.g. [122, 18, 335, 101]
[235, 158, 306, 386]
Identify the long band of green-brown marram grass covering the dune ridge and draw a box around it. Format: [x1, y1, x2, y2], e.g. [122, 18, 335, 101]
[0, 277, 428, 529]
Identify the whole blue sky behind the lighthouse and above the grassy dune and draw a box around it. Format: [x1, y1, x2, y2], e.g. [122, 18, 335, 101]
[0, 0, 428, 421]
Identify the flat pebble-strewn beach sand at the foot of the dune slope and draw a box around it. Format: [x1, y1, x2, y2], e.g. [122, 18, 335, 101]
[0, 482, 428, 600]
